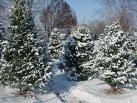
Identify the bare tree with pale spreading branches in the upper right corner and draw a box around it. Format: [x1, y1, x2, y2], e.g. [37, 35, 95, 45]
[101, 0, 137, 31]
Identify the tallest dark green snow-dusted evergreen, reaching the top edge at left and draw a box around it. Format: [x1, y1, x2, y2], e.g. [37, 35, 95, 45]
[0, 0, 50, 92]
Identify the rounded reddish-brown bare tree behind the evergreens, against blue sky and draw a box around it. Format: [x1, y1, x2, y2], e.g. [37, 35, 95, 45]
[41, 0, 77, 34]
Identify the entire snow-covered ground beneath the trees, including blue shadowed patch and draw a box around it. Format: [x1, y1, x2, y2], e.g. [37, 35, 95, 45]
[0, 71, 137, 103]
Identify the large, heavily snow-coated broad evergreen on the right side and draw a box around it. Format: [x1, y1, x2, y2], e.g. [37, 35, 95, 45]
[93, 22, 137, 89]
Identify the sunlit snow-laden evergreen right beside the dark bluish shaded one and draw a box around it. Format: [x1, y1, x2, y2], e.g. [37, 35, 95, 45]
[73, 26, 94, 80]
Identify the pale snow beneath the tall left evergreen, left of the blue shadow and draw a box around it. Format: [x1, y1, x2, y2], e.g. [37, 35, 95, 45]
[0, 87, 62, 103]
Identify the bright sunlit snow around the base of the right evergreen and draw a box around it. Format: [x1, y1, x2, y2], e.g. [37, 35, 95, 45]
[65, 79, 137, 103]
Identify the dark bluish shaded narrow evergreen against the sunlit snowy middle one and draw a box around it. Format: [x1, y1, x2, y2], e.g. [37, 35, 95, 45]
[63, 36, 79, 80]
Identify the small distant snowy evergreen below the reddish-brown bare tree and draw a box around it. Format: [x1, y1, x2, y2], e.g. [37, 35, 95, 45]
[48, 28, 62, 61]
